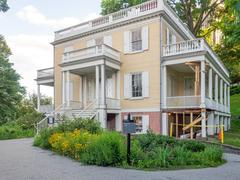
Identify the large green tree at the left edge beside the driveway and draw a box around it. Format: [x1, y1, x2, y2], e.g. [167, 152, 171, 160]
[0, 35, 25, 124]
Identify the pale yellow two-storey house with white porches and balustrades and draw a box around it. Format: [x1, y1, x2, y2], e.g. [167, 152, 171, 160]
[37, 0, 230, 138]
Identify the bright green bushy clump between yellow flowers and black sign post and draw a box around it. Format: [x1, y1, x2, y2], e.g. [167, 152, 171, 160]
[81, 132, 126, 166]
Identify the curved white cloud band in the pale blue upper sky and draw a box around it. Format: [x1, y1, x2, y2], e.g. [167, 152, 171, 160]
[16, 5, 99, 28]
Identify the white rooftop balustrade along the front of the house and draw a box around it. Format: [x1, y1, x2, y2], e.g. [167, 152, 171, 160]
[55, 0, 161, 40]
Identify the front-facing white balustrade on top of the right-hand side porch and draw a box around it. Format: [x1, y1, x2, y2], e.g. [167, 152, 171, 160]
[163, 38, 205, 56]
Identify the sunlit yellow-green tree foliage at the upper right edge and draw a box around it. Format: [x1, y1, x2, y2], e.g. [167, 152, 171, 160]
[215, 0, 240, 83]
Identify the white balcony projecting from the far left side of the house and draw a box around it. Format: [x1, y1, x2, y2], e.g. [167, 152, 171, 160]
[36, 67, 54, 86]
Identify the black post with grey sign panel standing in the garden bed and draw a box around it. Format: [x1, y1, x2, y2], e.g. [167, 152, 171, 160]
[123, 114, 136, 165]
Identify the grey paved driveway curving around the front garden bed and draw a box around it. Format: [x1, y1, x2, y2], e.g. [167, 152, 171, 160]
[0, 139, 240, 180]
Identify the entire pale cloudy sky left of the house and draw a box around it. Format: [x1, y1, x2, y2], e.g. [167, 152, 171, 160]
[0, 0, 100, 96]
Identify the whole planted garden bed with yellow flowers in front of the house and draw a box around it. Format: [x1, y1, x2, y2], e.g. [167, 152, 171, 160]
[34, 119, 224, 170]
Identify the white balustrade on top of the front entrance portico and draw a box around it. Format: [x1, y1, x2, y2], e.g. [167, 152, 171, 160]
[62, 44, 120, 63]
